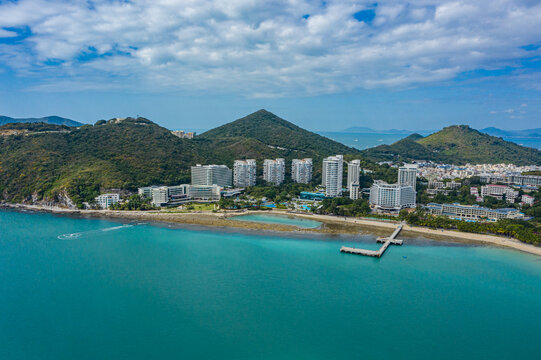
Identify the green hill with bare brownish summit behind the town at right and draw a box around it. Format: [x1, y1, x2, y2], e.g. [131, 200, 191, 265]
[362, 125, 541, 165]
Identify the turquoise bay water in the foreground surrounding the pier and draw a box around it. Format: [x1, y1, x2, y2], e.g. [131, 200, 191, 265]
[0, 211, 541, 360]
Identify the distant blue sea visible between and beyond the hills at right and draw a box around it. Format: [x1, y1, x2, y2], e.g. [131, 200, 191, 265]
[318, 131, 541, 150]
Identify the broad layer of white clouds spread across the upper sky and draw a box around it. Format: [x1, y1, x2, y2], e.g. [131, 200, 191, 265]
[0, 0, 541, 97]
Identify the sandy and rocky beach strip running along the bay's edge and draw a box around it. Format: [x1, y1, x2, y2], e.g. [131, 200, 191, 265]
[4, 203, 541, 256]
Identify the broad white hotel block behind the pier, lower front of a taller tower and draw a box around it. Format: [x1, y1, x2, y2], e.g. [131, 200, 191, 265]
[370, 180, 416, 212]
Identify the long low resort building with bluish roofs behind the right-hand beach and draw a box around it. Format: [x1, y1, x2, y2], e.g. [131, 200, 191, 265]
[425, 203, 524, 221]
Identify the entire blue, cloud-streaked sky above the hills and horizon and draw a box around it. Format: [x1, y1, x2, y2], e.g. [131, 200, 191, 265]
[0, 0, 541, 131]
